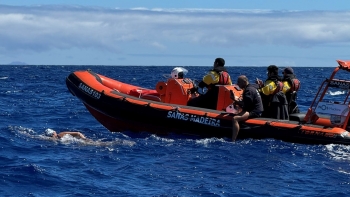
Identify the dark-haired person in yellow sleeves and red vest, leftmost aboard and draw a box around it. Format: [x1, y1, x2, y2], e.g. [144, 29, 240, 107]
[187, 58, 232, 110]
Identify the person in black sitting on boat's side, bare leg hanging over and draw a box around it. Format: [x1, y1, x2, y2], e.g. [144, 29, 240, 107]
[231, 75, 264, 141]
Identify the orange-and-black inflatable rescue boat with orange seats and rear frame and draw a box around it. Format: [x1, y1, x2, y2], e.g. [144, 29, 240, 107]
[66, 60, 350, 144]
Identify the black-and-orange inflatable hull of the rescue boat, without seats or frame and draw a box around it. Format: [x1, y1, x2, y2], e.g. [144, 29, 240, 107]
[66, 71, 350, 144]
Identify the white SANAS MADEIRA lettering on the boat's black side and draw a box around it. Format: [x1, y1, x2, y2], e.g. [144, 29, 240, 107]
[167, 111, 221, 127]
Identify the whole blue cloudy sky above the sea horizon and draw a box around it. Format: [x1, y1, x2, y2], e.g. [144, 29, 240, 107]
[0, 0, 350, 67]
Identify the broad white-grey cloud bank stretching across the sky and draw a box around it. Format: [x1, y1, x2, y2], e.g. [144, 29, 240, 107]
[0, 5, 350, 53]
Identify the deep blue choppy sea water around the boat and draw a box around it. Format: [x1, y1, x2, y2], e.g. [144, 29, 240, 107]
[0, 66, 350, 196]
